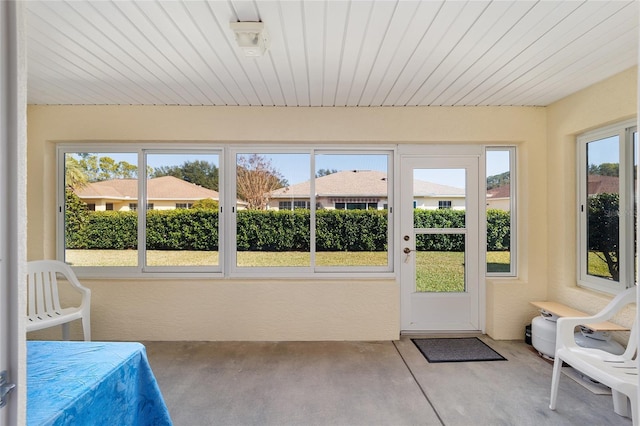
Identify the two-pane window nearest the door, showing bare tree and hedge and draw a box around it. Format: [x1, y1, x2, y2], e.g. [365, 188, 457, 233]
[231, 149, 392, 273]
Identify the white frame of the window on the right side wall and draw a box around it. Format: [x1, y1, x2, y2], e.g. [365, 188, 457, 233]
[576, 119, 637, 294]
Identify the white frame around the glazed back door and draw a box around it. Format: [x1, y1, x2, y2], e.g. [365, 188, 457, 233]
[394, 144, 487, 334]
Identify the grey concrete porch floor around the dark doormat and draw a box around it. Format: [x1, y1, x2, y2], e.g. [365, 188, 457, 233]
[145, 336, 631, 426]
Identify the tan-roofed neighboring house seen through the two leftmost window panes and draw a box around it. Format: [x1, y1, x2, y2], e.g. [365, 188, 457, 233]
[75, 176, 220, 211]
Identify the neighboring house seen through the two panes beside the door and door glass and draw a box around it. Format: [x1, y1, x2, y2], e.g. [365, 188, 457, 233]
[267, 170, 465, 210]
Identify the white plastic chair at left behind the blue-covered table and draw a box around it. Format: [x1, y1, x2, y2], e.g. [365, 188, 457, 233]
[27, 260, 91, 341]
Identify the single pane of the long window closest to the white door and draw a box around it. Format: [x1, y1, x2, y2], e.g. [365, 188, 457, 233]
[315, 154, 389, 266]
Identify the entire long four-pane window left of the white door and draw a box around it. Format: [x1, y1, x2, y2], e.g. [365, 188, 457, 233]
[58, 144, 393, 276]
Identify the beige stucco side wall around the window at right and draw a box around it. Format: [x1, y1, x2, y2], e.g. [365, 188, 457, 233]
[546, 68, 638, 325]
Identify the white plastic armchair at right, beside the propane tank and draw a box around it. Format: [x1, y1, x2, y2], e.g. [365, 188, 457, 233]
[549, 286, 640, 424]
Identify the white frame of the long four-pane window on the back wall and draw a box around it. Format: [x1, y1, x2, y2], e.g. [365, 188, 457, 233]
[56, 142, 396, 279]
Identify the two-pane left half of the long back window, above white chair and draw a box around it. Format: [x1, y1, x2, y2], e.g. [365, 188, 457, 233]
[59, 148, 220, 271]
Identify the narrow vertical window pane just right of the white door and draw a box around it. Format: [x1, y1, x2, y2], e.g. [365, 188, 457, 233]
[486, 149, 512, 273]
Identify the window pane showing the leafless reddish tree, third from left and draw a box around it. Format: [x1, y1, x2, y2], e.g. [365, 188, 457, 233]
[236, 153, 311, 267]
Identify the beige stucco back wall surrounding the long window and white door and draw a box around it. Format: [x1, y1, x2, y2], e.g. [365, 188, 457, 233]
[28, 102, 548, 340]
